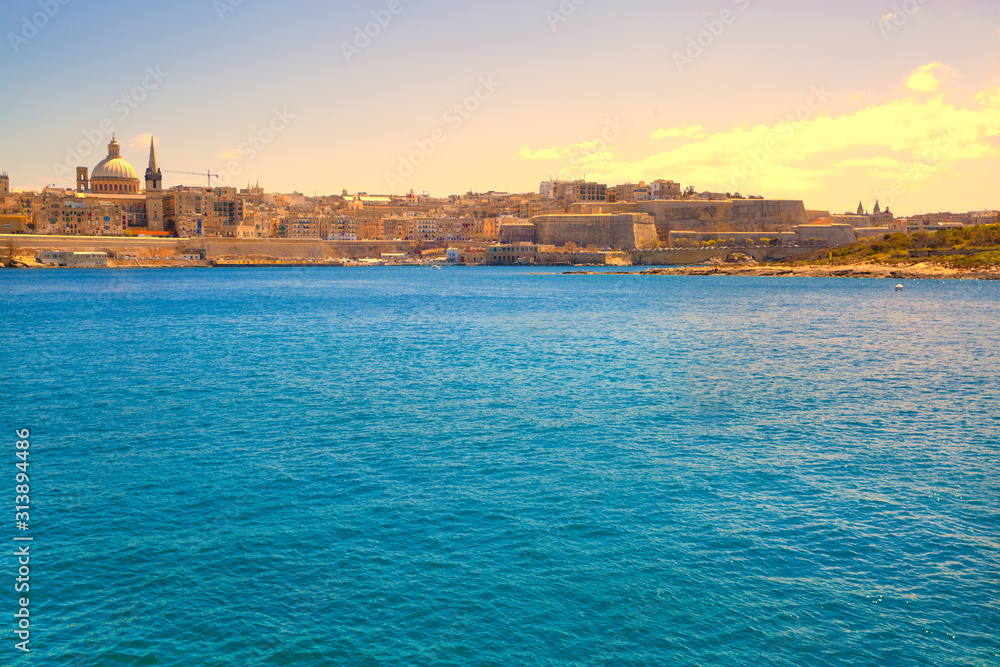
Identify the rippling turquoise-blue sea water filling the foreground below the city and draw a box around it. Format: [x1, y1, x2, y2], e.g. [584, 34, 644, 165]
[0, 269, 1000, 667]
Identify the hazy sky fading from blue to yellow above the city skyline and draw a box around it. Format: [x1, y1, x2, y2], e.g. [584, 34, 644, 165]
[0, 0, 1000, 215]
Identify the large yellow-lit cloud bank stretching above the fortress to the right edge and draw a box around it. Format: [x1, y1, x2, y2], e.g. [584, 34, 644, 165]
[560, 90, 1000, 198]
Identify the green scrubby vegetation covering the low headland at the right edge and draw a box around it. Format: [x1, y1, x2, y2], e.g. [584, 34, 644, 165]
[787, 225, 1000, 268]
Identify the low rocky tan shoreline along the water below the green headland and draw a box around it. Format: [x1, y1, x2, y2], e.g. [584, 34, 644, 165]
[562, 264, 1000, 280]
